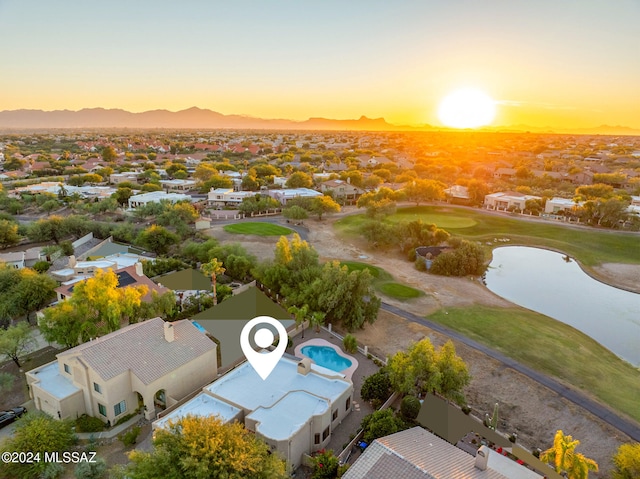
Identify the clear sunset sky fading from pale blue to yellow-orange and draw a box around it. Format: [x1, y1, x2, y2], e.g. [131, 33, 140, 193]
[0, 0, 640, 128]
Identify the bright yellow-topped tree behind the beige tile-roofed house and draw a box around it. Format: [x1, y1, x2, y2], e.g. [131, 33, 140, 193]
[39, 269, 149, 347]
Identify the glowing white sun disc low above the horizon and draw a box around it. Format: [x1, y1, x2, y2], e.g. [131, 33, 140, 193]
[438, 88, 496, 128]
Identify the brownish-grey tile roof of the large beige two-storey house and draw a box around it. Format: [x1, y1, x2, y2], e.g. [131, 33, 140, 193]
[57, 318, 216, 384]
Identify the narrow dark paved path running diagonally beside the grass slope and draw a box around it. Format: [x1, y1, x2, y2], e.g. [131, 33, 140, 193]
[381, 303, 640, 442]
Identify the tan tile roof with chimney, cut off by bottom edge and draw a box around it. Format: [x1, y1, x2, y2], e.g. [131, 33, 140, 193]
[342, 426, 551, 479]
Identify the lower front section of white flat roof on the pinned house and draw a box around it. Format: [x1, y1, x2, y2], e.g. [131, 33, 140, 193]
[247, 391, 329, 441]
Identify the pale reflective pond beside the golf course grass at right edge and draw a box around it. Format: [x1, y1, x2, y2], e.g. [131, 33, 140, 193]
[485, 246, 640, 366]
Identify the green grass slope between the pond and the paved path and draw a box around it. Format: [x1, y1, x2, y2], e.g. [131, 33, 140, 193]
[429, 306, 640, 422]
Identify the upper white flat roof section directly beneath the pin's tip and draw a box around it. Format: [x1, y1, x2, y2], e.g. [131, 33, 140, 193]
[205, 357, 353, 411]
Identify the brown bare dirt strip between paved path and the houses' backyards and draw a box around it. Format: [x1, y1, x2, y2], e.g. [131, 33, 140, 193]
[354, 311, 630, 477]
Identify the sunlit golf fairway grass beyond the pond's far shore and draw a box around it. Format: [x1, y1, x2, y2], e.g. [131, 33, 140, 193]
[335, 206, 640, 266]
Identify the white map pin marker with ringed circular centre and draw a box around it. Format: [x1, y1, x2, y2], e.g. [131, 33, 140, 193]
[240, 316, 288, 380]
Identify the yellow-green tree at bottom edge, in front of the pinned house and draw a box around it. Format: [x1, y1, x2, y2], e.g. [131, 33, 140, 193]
[124, 416, 289, 479]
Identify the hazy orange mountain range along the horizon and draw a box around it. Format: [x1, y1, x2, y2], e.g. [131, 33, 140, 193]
[0, 107, 640, 135]
